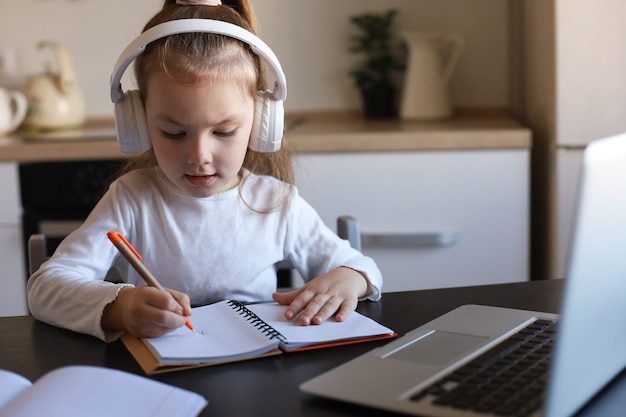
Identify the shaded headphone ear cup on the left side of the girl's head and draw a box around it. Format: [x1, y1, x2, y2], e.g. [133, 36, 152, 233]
[115, 90, 152, 154]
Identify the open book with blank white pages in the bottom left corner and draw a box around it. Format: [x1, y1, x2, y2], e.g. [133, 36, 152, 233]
[0, 366, 207, 417]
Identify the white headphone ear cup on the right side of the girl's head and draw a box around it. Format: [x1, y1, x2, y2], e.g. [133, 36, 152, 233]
[248, 92, 285, 152]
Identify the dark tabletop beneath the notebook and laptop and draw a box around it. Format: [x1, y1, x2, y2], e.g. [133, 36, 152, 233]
[0, 280, 626, 417]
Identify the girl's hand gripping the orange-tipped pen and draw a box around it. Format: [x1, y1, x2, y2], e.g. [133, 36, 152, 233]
[102, 286, 191, 337]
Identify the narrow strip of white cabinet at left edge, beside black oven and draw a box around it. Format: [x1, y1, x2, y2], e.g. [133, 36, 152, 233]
[0, 162, 28, 316]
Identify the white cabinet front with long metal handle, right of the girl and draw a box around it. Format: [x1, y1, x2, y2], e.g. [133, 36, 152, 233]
[295, 149, 530, 292]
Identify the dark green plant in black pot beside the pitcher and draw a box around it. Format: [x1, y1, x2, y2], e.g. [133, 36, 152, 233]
[349, 9, 404, 118]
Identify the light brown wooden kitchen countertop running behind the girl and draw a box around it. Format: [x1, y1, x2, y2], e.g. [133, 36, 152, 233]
[0, 112, 531, 162]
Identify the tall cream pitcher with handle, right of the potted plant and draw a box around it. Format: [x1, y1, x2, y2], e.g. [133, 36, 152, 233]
[400, 32, 465, 120]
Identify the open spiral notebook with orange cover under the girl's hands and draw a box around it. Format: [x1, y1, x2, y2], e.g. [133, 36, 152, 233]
[122, 300, 397, 374]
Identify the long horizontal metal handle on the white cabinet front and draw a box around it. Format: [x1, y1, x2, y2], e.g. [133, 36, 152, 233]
[361, 231, 459, 248]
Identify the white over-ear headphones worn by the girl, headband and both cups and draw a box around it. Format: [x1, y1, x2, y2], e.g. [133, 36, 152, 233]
[111, 19, 287, 153]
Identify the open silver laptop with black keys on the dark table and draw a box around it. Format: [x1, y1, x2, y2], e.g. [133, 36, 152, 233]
[300, 134, 626, 417]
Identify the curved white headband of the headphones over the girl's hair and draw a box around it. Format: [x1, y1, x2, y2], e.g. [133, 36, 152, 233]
[111, 19, 287, 103]
